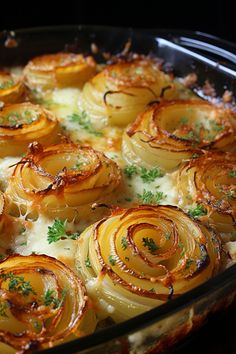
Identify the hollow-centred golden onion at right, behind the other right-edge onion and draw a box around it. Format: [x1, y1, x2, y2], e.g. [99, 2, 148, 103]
[122, 101, 236, 171]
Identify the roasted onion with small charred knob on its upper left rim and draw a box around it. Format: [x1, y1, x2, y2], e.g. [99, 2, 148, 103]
[7, 142, 121, 220]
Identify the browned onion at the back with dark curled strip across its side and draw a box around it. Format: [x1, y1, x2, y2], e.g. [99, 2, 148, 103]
[79, 59, 174, 126]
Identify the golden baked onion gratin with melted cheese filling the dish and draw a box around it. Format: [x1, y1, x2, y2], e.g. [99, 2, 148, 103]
[0, 49, 236, 354]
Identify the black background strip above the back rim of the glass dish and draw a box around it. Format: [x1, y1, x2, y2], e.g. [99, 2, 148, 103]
[0, 0, 236, 42]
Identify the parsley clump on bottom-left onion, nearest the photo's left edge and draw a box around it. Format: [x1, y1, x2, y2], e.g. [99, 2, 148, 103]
[0, 272, 36, 296]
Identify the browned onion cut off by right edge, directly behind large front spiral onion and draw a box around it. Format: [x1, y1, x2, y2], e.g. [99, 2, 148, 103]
[176, 152, 236, 232]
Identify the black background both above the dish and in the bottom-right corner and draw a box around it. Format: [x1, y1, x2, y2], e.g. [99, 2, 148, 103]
[0, 0, 236, 354]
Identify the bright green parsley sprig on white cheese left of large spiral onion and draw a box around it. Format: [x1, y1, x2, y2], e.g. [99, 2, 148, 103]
[47, 219, 80, 244]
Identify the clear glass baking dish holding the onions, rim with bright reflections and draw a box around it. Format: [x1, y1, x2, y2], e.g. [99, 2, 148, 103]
[0, 26, 236, 354]
